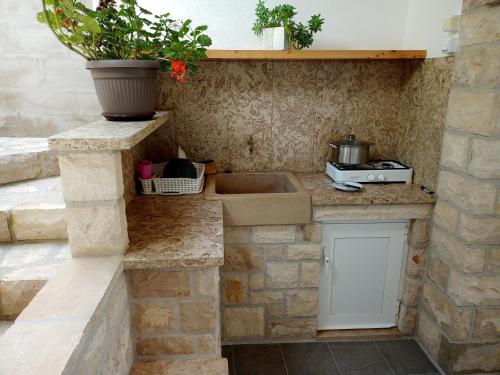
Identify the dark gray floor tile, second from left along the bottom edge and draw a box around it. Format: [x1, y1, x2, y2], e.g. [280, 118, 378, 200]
[281, 342, 339, 375]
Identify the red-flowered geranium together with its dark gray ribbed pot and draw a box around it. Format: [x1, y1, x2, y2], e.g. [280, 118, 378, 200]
[37, 0, 212, 120]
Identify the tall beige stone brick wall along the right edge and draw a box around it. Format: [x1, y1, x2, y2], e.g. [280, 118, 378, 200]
[418, 0, 500, 374]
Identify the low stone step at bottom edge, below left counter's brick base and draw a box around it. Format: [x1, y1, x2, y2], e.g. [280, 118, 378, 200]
[130, 358, 229, 375]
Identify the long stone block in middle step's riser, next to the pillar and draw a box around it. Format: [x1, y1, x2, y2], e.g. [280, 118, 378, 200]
[11, 203, 68, 241]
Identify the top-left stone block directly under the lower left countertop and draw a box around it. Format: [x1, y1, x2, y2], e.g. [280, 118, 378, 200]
[128, 270, 191, 298]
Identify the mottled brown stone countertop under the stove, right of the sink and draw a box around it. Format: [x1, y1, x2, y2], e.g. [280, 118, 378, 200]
[294, 173, 435, 206]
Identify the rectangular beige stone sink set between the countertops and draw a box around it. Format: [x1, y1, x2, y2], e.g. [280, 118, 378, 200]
[205, 172, 311, 226]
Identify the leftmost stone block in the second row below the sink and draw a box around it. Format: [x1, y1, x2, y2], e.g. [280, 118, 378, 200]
[222, 246, 263, 272]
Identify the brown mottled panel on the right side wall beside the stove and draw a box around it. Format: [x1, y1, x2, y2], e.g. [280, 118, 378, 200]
[396, 57, 454, 191]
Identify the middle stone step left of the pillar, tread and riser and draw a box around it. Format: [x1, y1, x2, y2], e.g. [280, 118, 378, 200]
[0, 177, 68, 242]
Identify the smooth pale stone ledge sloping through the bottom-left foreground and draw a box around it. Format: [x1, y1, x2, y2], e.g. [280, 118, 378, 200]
[0, 257, 122, 375]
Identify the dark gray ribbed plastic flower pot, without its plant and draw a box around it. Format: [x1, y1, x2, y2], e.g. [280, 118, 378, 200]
[85, 60, 160, 121]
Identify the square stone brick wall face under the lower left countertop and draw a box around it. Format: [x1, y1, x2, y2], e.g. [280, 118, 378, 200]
[128, 267, 221, 360]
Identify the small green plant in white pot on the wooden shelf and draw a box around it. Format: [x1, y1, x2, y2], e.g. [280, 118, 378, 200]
[252, 0, 325, 50]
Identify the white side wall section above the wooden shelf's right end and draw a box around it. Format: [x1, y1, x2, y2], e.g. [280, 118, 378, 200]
[404, 0, 462, 57]
